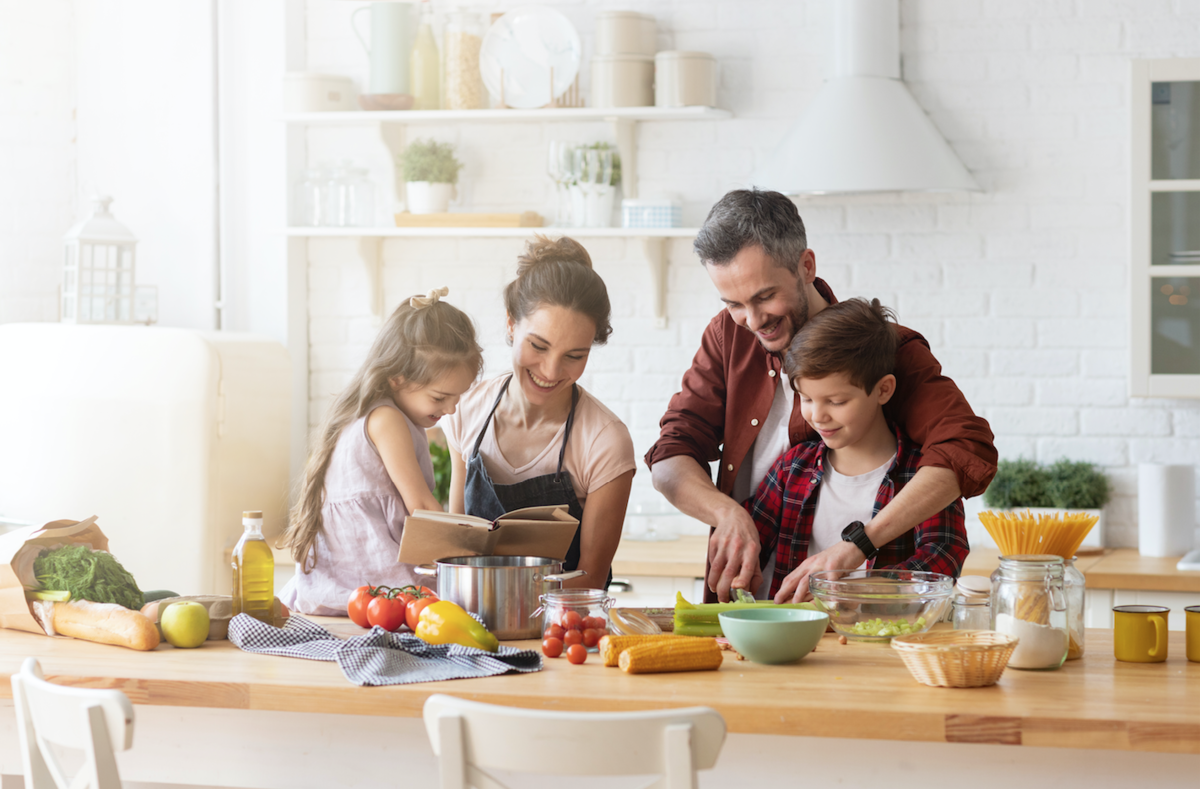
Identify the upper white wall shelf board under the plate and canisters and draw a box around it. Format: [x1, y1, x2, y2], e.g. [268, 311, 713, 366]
[283, 107, 733, 125]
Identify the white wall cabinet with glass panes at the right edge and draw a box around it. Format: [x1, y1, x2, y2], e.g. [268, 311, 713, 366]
[1129, 58, 1200, 397]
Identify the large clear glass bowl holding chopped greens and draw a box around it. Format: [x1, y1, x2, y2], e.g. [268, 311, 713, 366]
[809, 570, 954, 642]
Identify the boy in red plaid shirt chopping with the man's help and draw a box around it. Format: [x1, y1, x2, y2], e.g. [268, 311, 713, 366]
[744, 299, 970, 602]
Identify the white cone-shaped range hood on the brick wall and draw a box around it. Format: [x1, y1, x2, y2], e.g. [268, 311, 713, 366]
[754, 0, 979, 194]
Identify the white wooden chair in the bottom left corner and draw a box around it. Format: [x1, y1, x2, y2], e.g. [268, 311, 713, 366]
[12, 657, 133, 789]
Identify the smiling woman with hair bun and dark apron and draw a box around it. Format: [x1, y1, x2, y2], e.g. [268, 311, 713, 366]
[445, 236, 636, 586]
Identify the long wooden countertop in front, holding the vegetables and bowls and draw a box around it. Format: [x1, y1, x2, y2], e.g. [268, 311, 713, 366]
[0, 620, 1200, 754]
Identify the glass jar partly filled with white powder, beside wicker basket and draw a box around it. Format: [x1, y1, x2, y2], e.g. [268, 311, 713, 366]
[991, 554, 1068, 669]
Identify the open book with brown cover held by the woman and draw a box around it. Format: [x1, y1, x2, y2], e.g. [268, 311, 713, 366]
[398, 505, 580, 565]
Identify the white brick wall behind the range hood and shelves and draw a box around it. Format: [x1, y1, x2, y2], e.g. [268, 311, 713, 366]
[295, 0, 1200, 546]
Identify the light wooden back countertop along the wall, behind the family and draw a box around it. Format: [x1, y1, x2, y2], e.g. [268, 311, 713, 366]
[612, 536, 1200, 592]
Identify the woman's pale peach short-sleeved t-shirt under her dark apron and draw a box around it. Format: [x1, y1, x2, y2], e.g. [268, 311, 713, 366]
[442, 373, 637, 505]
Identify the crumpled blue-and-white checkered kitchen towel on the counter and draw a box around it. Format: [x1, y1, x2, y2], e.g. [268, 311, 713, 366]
[229, 614, 541, 685]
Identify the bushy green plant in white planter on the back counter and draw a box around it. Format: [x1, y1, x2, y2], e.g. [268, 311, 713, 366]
[983, 458, 1111, 548]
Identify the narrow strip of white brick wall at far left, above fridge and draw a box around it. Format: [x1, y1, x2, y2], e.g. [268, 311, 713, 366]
[0, 0, 76, 323]
